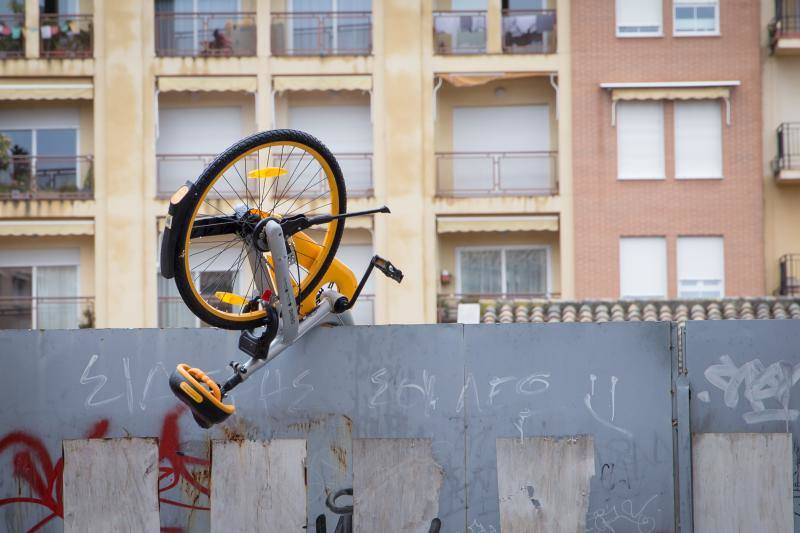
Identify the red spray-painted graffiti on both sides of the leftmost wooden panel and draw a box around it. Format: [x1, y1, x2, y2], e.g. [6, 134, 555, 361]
[0, 405, 210, 533]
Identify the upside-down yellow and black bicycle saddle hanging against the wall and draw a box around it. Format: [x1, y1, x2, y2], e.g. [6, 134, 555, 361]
[169, 363, 236, 429]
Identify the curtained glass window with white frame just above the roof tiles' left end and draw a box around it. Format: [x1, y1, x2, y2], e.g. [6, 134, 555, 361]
[457, 246, 550, 295]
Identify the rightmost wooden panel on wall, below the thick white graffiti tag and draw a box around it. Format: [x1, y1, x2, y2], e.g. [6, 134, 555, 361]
[692, 433, 794, 533]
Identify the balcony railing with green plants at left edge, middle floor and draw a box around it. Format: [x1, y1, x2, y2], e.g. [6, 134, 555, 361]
[0, 155, 94, 200]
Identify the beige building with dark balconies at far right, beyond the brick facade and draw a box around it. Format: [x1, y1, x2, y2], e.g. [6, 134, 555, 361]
[761, 0, 800, 296]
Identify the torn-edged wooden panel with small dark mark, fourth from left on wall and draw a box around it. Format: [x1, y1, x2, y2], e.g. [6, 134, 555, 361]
[497, 435, 595, 533]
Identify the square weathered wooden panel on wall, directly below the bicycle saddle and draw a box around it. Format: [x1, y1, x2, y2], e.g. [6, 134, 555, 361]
[211, 439, 306, 533]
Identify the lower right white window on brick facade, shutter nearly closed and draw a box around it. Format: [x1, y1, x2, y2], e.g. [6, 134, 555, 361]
[678, 237, 725, 298]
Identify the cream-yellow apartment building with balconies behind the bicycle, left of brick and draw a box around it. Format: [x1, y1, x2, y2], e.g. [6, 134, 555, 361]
[0, 0, 573, 328]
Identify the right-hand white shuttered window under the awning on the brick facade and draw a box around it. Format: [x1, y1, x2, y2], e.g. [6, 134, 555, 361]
[675, 100, 722, 179]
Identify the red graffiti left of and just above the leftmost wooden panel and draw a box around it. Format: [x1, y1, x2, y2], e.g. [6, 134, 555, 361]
[0, 419, 109, 532]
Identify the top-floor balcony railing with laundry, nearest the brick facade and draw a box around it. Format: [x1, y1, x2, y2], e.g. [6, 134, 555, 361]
[503, 9, 556, 54]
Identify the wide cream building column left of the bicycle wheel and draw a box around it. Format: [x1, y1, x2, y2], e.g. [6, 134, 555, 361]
[94, 0, 152, 328]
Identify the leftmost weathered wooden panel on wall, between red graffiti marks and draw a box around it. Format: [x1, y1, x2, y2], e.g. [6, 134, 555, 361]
[64, 438, 160, 533]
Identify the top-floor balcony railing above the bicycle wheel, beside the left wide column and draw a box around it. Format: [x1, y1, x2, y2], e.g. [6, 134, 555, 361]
[156, 12, 256, 57]
